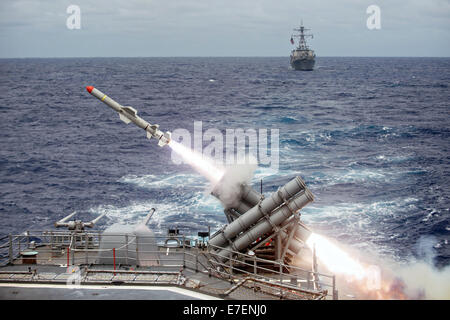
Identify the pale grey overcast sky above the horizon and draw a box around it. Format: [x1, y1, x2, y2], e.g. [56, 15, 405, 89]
[0, 0, 450, 58]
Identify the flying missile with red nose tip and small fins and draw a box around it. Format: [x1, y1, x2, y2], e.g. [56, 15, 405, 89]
[86, 86, 171, 147]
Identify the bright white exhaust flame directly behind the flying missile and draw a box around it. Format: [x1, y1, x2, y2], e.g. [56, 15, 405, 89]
[168, 140, 225, 185]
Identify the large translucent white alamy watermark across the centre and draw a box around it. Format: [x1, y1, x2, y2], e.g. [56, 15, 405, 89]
[172, 121, 280, 171]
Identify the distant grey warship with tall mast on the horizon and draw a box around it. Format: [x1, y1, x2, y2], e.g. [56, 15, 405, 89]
[291, 22, 316, 71]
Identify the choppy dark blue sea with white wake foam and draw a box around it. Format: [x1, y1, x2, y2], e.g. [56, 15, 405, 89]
[0, 57, 450, 267]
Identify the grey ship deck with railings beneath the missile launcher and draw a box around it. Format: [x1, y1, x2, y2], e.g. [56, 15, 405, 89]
[0, 233, 337, 300]
